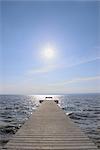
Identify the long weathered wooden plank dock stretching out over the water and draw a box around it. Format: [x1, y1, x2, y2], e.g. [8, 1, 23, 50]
[4, 101, 98, 150]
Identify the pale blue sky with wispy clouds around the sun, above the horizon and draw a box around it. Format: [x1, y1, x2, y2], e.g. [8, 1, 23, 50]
[0, 1, 100, 94]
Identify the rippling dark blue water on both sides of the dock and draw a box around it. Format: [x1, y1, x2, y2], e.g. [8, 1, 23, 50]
[0, 94, 100, 148]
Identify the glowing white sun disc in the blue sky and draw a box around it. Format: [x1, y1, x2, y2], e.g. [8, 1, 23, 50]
[43, 46, 55, 59]
